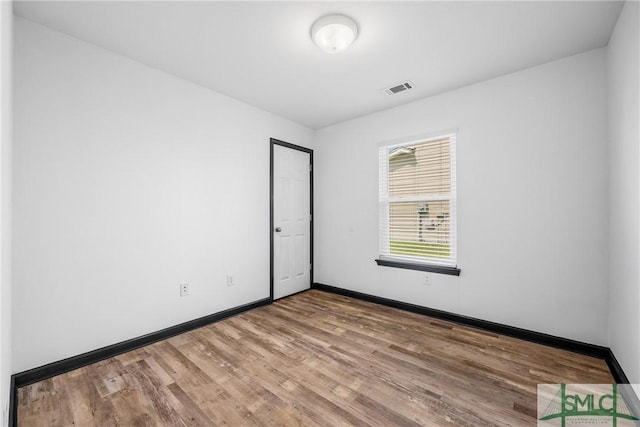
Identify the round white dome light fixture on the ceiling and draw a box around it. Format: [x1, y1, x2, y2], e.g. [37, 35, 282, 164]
[311, 15, 358, 53]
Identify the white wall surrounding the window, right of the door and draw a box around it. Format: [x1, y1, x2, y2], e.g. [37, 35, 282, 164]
[315, 49, 608, 345]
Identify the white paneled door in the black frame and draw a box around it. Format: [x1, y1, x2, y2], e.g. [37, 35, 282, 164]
[272, 144, 311, 299]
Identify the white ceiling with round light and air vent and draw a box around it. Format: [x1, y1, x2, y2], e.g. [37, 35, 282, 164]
[14, 1, 622, 129]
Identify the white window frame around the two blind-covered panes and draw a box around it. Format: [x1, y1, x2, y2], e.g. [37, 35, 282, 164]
[375, 129, 460, 276]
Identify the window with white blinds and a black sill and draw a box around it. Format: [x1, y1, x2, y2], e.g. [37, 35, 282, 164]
[376, 133, 460, 275]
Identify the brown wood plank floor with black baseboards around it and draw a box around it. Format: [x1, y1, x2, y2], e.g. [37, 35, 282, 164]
[18, 290, 613, 427]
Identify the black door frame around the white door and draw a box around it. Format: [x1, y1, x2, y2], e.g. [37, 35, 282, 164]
[269, 138, 315, 302]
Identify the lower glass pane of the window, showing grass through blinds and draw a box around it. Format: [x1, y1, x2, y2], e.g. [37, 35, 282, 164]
[389, 200, 451, 258]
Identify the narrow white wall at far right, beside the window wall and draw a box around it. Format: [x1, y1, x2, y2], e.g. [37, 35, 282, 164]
[607, 1, 640, 391]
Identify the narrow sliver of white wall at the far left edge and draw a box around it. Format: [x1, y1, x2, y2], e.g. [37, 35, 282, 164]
[0, 1, 13, 425]
